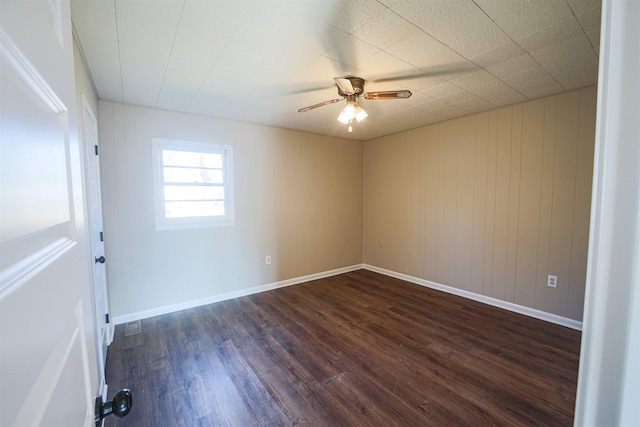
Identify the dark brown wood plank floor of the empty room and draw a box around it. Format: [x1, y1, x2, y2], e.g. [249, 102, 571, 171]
[105, 270, 581, 426]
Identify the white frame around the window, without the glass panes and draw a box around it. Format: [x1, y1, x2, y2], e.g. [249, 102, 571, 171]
[151, 138, 235, 230]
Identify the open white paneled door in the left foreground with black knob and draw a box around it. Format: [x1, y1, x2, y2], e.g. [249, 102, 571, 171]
[0, 0, 99, 427]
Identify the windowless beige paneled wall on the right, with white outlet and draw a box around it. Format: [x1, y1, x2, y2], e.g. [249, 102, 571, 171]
[363, 87, 596, 320]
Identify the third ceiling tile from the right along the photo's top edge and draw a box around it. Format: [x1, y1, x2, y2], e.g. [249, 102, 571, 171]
[391, 0, 510, 58]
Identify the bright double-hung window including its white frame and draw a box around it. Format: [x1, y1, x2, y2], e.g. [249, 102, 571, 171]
[152, 138, 234, 230]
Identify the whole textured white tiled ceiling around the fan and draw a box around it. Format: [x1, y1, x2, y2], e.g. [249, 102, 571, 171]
[72, 0, 601, 140]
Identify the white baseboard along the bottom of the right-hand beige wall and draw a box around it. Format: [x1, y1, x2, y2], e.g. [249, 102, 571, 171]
[362, 264, 582, 331]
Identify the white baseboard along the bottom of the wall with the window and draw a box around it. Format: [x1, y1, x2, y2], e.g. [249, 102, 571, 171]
[113, 264, 363, 325]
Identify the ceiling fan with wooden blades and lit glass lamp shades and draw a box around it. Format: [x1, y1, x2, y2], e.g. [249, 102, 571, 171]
[298, 77, 411, 132]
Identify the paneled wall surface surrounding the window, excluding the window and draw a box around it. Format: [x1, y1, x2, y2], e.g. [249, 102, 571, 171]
[99, 101, 362, 317]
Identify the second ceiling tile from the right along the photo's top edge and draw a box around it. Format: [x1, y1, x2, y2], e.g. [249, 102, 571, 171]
[475, 0, 573, 39]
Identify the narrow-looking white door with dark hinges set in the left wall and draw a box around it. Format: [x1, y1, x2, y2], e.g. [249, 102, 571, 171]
[81, 96, 113, 386]
